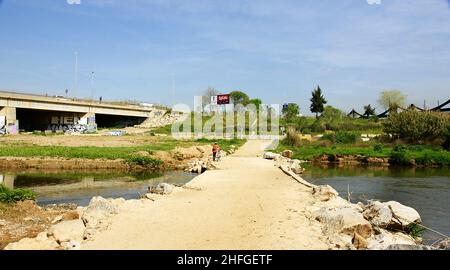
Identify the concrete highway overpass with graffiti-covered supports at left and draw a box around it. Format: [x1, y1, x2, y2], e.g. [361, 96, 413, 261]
[0, 91, 166, 133]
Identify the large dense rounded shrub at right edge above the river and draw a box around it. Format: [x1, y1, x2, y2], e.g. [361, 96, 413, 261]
[383, 110, 449, 142]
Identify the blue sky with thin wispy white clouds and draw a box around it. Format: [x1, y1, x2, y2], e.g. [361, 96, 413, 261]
[0, 0, 450, 114]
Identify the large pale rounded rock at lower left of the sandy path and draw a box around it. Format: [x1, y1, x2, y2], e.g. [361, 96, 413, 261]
[49, 219, 85, 243]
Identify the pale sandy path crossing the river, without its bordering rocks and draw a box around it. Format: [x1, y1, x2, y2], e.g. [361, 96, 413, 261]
[82, 141, 328, 250]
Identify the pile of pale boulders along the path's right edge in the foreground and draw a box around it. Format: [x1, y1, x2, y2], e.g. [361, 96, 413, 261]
[312, 186, 431, 250]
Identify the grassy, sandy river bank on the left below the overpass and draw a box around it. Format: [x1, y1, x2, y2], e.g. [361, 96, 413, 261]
[0, 134, 244, 171]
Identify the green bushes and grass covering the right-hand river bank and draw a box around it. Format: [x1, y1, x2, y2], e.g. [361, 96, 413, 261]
[277, 103, 450, 167]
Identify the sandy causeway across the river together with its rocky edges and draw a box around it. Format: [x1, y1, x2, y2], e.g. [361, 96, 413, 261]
[3, 142, 446, 250]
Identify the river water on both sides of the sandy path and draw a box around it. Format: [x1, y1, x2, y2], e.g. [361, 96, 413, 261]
[0, 166, 450, 243]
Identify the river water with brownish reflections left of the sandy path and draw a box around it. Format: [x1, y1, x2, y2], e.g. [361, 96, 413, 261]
[0, 170, 196, 206]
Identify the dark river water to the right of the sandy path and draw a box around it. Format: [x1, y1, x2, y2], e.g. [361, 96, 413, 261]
[303, 166, 450, 244]
